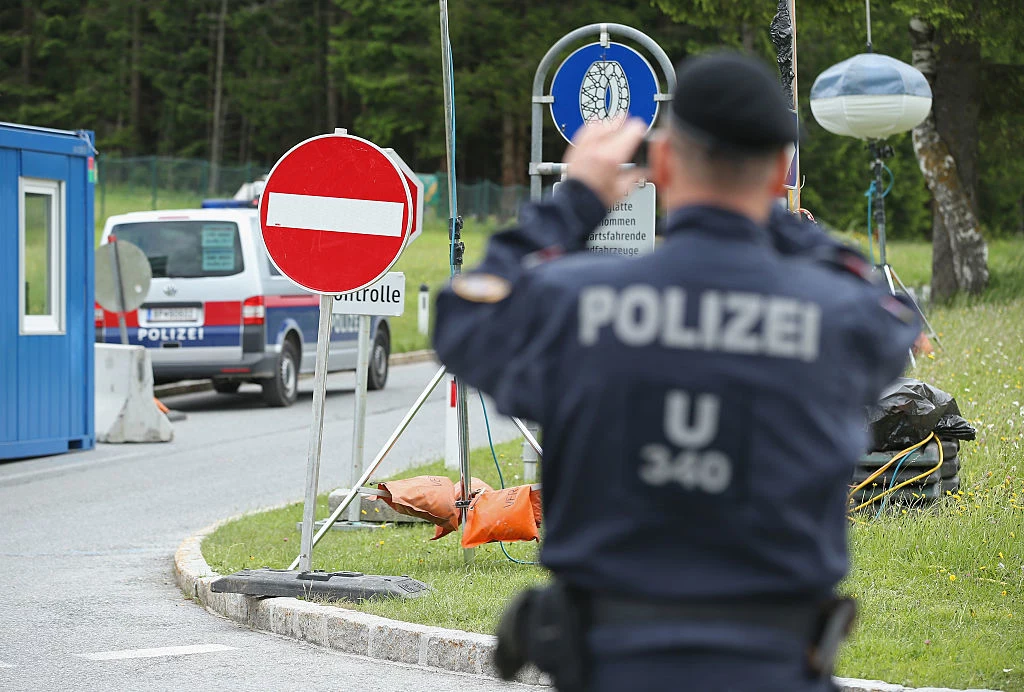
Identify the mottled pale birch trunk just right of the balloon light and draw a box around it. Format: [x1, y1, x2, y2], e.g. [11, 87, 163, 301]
[910, 17, 988, 300]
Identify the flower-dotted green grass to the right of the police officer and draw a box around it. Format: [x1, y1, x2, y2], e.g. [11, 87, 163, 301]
[840, 241, 1024, 691]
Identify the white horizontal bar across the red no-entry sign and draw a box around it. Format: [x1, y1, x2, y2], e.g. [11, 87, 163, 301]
[266, 192, 406, 237]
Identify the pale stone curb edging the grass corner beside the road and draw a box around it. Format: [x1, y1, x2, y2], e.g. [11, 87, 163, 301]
[174, 517, 995, 692]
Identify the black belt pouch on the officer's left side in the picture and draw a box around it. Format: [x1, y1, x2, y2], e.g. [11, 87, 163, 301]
[495, 581, 589, 692]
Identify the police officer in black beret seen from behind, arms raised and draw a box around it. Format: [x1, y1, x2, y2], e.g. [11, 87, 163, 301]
[434, 52, 920, 692]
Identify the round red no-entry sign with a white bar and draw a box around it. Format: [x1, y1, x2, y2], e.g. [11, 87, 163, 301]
[259, 134, 413, 294]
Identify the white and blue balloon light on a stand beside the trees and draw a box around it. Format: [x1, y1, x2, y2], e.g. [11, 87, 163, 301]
[811, 53, 932, 139]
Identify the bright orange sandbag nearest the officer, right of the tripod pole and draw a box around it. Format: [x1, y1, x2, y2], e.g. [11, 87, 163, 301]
[462, 485, 540, 548]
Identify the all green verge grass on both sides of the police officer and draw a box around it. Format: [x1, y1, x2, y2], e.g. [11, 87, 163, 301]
[203, 240, 1024, 692]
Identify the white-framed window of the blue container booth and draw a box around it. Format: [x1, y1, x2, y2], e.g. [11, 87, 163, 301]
[18, 178, 65, 334]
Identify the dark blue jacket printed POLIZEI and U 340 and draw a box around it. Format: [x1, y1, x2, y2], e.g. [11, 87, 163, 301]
[434, 181, 920, 601]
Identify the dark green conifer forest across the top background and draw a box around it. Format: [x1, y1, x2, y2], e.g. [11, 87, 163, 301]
[0, 0, 1024, 245]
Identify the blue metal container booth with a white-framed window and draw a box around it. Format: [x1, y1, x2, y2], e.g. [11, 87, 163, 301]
[0, 123, 95, 460]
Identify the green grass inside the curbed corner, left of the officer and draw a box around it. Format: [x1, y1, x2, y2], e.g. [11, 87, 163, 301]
[203, 441, 545, 632]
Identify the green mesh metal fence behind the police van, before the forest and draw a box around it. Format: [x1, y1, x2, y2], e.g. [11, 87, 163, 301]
[96, 157, 529, 222]
